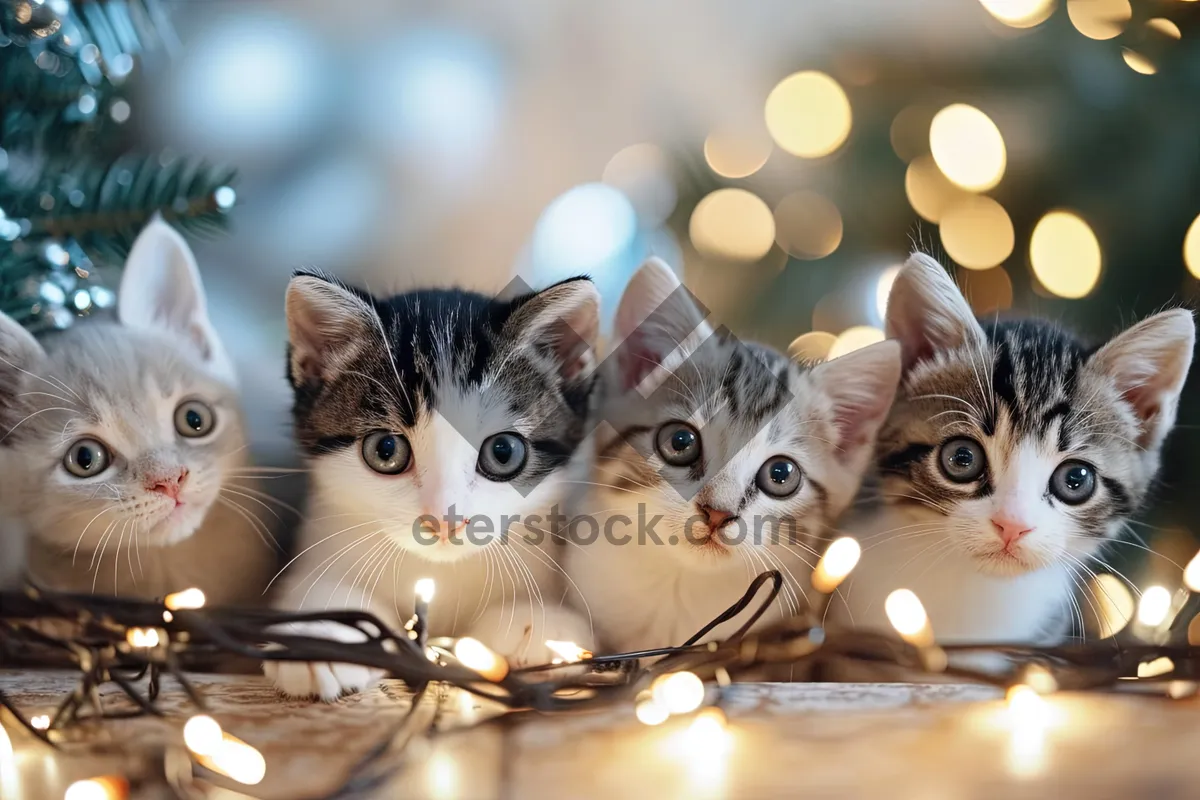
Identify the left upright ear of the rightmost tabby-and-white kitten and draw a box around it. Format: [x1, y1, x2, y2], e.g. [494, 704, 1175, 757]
[884, 253, 986, 369]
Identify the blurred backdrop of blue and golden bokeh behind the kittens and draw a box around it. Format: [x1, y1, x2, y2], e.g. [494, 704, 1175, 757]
[0, 0, 1200, 638]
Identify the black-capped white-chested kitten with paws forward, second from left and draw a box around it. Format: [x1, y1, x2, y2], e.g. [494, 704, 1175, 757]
[264, 273, 599, 699]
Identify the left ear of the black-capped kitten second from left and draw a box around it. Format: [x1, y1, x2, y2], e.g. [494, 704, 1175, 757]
[284, 272, 380, 389]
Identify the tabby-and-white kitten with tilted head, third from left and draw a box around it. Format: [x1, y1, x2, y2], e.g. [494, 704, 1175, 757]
[568, 259, 900, 651]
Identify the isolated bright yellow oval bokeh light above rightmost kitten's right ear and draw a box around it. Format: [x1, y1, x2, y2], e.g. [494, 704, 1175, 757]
[1030, 211, 1103, 300]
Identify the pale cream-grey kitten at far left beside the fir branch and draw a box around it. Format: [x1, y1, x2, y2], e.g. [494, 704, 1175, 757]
[0, 219, 272, 603]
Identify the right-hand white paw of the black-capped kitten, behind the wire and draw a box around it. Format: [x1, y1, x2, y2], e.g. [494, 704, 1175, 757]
[468, 601, 593, 669]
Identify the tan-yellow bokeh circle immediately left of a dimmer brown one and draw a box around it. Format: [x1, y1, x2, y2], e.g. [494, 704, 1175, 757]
[688, 188, 775, 261]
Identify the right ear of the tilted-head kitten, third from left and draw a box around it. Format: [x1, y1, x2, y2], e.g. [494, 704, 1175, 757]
[809, 342, 901, 453]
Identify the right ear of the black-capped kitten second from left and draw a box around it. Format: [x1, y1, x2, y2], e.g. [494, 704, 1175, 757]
[504, 277, 600, 380]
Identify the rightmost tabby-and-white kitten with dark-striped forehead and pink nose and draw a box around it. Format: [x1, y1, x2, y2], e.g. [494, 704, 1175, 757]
[834, 253, 1195, 642]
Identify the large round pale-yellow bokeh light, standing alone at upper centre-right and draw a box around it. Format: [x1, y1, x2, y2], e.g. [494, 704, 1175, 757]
[767, 71, 851, 158]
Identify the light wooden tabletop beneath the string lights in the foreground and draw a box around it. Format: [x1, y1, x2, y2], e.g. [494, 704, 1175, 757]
[0, 672, 1200, 800]
